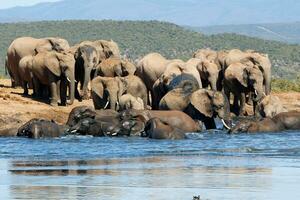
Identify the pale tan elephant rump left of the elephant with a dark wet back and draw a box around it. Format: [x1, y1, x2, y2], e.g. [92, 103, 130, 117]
[135, 53, 180, 109]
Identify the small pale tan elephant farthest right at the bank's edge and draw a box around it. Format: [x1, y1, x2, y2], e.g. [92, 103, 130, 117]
[255, 95, 287, 118]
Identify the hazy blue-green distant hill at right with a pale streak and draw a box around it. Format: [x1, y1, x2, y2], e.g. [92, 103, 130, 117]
[188, 22, 300, 44]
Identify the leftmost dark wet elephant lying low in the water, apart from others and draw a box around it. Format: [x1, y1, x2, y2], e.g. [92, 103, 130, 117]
[17, 118, 65, 139]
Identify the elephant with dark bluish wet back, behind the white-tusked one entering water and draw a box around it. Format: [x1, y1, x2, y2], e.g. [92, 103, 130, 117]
[152, 73, 200, 109]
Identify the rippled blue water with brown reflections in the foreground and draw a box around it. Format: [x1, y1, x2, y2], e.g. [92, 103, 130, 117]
[0, 131, 300, 200]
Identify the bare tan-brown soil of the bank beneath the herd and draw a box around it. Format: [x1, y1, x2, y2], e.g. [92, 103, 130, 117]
[0, 79, 300, 135]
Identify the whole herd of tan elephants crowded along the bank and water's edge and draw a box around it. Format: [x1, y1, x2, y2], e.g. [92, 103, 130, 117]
[5, 37, 298, 139]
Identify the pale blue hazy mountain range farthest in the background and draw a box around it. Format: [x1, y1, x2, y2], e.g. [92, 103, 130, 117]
[0, 0, 300, 26]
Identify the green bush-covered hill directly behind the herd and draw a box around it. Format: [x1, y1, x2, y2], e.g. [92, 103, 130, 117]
[0, 20, 300, 78]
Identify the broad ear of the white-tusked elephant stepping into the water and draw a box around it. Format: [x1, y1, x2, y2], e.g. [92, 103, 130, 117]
[190, 89, 213, 117]
